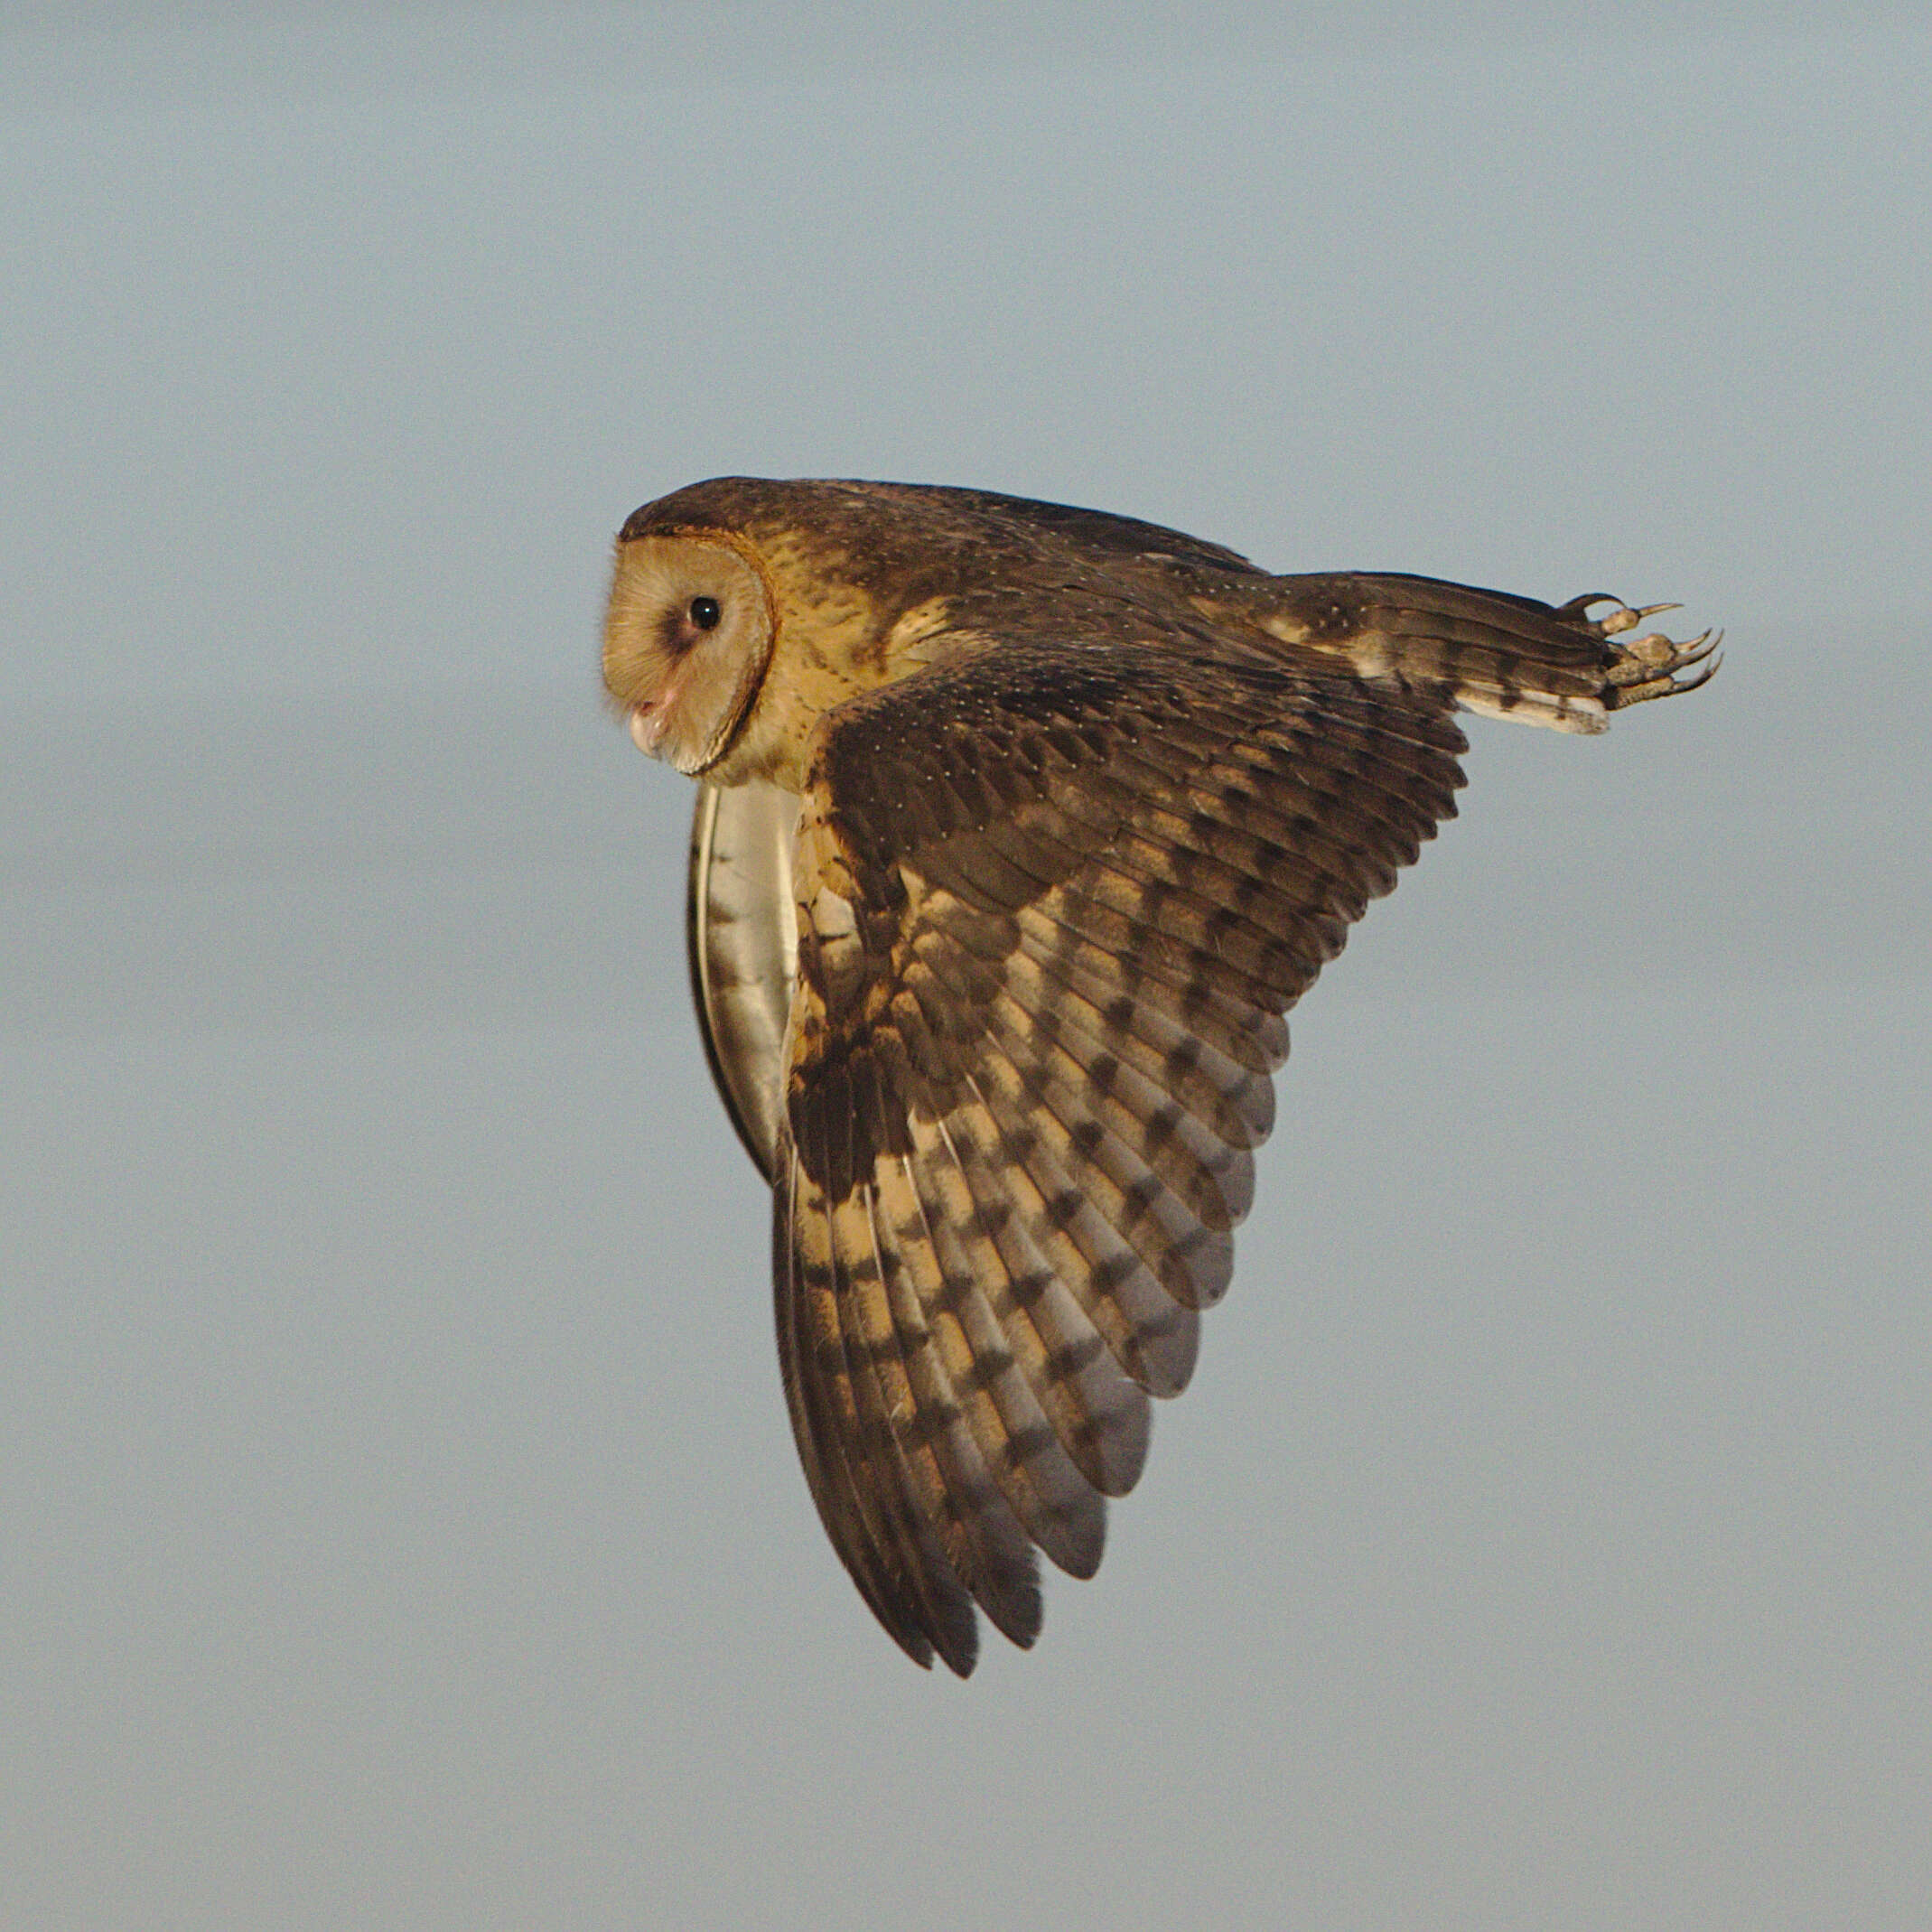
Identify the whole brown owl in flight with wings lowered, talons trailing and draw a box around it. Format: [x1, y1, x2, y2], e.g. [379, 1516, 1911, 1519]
[602, 477, 1715, 1675]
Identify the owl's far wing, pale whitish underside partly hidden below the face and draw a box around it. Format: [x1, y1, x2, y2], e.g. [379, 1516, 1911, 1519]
[684, 784, 798, 1181]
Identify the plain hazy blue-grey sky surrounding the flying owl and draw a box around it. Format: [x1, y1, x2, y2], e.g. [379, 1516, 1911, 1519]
[0, 11, 1932, 1932]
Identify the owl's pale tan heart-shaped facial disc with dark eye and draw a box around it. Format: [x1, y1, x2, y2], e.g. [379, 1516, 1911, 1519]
[602, 531, 777, 773]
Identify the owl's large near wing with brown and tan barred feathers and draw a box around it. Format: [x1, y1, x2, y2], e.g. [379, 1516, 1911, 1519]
[775, 638, 1462, 1673]
